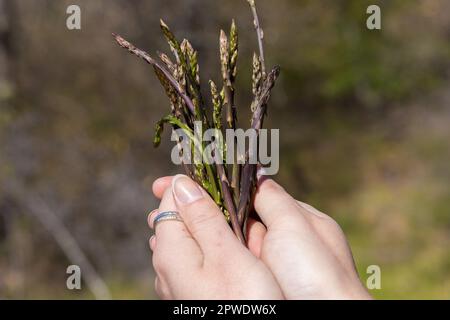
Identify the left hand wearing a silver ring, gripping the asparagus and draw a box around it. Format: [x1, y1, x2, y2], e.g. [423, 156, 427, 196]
[149, 175, 283, 299]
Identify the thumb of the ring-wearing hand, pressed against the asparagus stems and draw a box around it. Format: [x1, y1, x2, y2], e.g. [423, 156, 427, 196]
[172, 175, 240, 255]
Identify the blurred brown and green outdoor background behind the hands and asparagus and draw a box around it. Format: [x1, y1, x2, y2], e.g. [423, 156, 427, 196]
[0, 0, 450, 299]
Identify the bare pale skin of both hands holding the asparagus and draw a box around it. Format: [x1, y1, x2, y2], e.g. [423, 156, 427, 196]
[148, 176, 370, 299]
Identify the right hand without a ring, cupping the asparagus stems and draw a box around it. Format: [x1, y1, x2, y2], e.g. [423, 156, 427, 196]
[248, 178, 371, 299]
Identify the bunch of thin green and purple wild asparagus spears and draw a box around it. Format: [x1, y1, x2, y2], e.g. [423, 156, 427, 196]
[113, 0, 280, 244]
